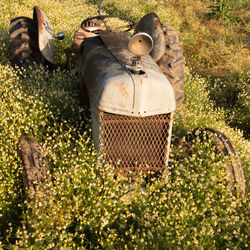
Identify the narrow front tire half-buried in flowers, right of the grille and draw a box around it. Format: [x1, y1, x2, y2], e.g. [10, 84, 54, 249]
[186, 127, 245, 196]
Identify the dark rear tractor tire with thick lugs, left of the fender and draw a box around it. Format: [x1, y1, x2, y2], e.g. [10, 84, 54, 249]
[9, 17, 44, 69]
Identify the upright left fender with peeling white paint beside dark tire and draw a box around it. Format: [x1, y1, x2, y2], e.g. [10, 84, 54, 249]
[33, 6, 55, 64]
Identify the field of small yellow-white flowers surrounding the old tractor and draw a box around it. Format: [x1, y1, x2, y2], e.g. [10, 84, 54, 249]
[0, 0, 250, 249]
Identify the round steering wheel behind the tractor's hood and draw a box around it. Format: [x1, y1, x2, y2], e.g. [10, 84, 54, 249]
[81, 15, 136, 34]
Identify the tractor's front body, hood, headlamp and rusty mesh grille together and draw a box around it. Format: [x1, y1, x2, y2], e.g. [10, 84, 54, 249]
[79, 30, 176, 173]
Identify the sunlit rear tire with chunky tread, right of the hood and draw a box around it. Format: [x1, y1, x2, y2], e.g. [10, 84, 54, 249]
[157, 24, 185, 107]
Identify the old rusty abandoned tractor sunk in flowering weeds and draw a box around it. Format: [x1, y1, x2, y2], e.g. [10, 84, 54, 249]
[9, 6, 245, 193]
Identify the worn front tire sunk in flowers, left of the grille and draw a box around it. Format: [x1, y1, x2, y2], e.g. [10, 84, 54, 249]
[18, 137, 48, 193]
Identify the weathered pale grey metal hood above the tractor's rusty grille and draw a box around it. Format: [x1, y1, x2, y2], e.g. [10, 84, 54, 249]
[80, 31, 176, 117]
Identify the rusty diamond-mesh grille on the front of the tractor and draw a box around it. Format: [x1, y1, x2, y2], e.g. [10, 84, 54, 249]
[100, 112, 172, 172]
